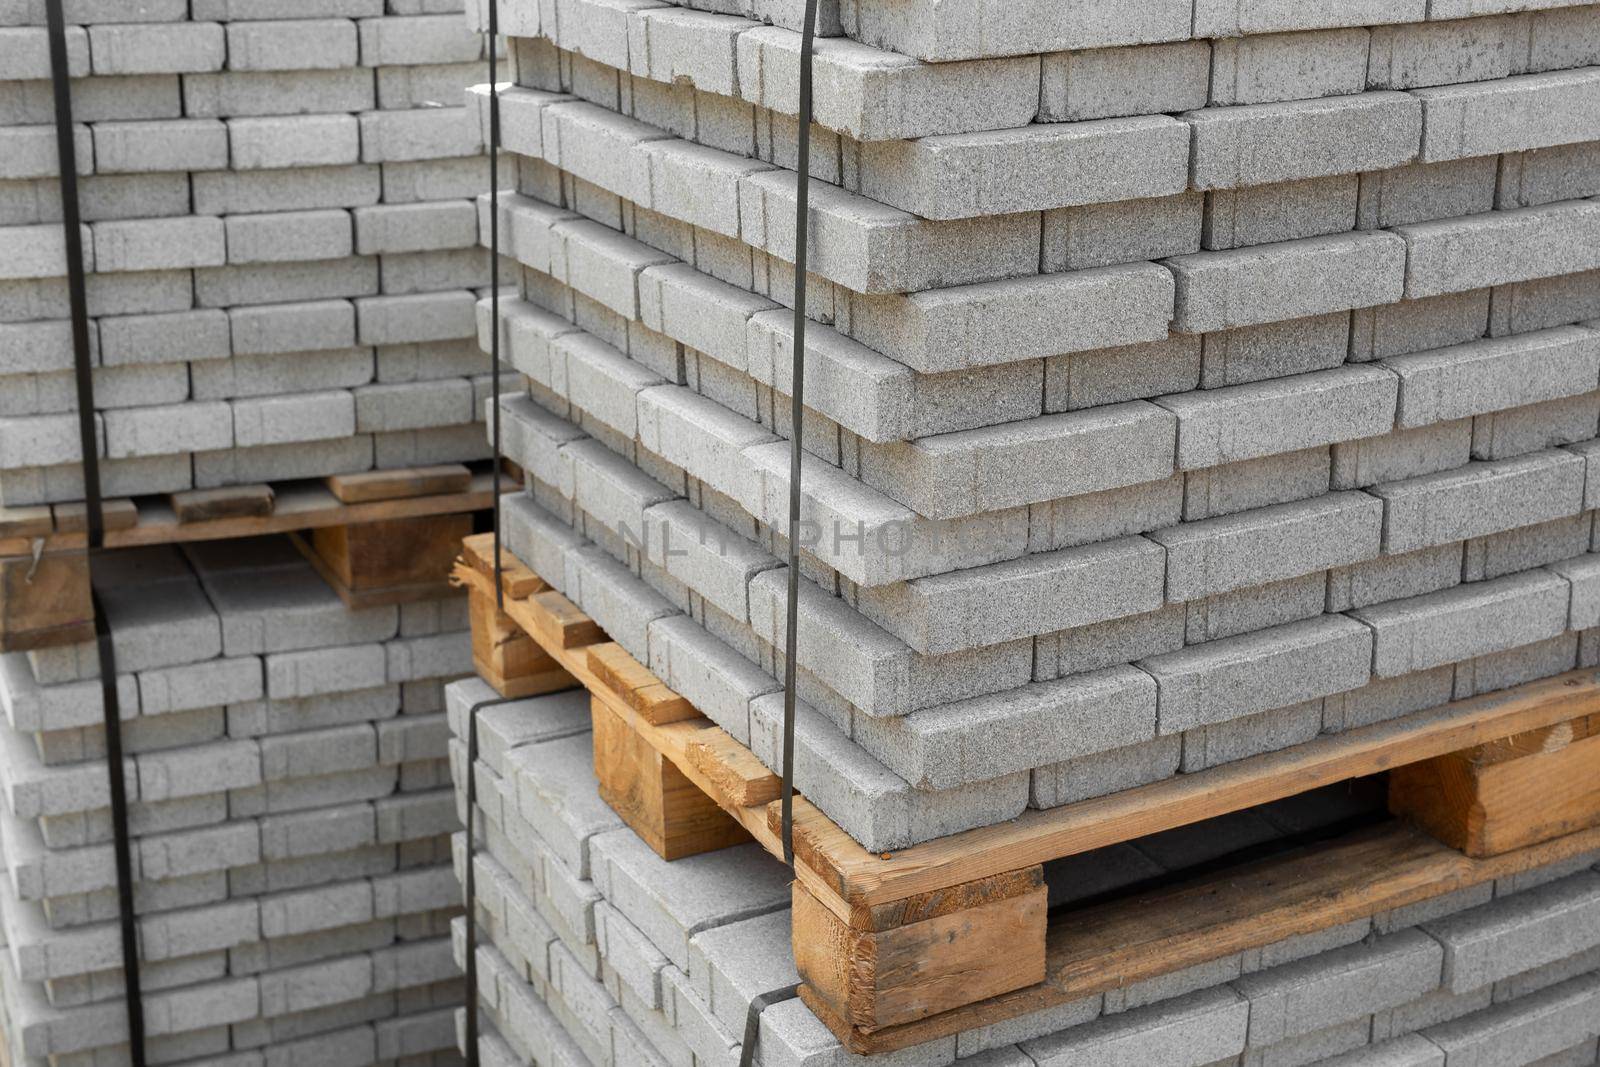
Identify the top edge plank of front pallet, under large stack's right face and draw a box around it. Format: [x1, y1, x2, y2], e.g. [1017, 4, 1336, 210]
[777, 669, 1600, 905]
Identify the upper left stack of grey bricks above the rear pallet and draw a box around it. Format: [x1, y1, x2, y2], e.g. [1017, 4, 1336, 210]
[0, 0, 515, 506]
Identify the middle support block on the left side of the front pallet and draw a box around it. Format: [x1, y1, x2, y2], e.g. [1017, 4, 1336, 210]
[589, 696, 750, 859]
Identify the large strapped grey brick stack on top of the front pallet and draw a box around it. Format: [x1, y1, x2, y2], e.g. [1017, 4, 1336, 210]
[472, 0, 1600, 851]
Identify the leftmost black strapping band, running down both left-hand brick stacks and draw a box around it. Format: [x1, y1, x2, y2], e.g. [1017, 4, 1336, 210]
[45, 0, 144, 1067]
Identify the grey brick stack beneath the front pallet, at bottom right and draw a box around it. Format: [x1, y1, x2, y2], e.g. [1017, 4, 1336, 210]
[446, 680, 1600, 1067]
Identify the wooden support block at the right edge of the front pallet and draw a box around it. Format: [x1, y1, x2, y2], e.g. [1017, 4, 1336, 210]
[1389, 717, 1600, 856]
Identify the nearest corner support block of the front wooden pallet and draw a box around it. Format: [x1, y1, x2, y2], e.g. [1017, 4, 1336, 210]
[794, 867, 1048, 1033]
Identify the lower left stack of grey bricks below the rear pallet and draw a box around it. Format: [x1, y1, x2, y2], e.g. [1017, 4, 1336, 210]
[0, 537, 472, 1067]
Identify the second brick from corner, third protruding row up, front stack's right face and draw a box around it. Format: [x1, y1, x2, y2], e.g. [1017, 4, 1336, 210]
[1160, 366, 1398, 470]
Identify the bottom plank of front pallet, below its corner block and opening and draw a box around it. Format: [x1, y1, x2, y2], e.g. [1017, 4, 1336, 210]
[851, 822, 1600, 1056]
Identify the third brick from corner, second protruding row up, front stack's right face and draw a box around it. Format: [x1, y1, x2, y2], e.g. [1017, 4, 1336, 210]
[1370, 450, 1584, 553]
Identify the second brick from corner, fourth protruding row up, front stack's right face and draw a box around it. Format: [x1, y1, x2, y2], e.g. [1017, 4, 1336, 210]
[1168, 234, 1401, 333]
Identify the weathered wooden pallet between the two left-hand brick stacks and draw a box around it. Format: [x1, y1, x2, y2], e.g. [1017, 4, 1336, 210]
[0, 464, 515, 651]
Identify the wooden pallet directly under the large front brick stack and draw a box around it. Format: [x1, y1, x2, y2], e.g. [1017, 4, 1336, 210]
[454, 539, 1600, 1054]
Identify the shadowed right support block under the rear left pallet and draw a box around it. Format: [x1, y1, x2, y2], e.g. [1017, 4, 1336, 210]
[296, 514, 472, 608]
